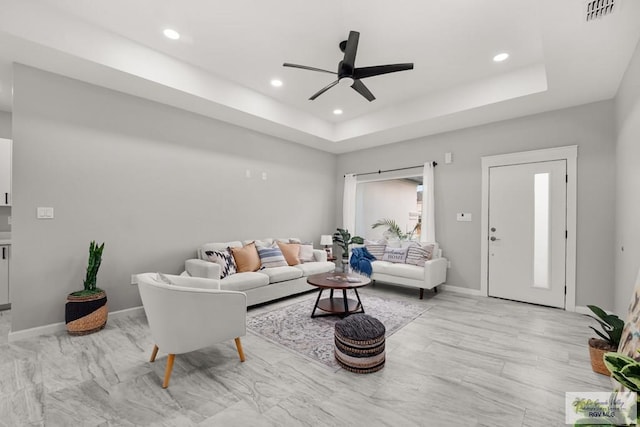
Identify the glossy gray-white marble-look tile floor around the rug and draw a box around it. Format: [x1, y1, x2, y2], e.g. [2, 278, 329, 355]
[0, 284, 611, 427]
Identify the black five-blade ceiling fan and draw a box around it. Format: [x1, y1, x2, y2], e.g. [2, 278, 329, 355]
[282, 31, 413, 102]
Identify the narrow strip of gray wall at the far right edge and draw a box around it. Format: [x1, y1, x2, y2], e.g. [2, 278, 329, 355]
[614, 38, 640, 315]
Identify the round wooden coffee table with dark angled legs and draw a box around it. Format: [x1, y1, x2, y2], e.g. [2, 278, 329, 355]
[307, 273, 371, 317]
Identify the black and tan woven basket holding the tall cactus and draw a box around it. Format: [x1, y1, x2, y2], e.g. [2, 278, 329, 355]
[65, 291, 109, 335]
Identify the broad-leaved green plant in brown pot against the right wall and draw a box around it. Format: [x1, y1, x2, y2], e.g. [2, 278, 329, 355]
[587, 305, 624, 375]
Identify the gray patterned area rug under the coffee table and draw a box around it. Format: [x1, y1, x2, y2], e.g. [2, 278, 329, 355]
[247, 291, 429, 369]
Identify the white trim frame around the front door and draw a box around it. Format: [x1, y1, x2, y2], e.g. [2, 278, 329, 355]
[480, 145, 578, 311]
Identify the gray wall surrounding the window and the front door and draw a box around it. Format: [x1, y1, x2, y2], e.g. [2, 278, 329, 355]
[336, 101, 615, 309]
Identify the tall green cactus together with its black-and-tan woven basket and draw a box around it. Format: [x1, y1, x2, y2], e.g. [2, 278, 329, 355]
[65, 240, 108, 335]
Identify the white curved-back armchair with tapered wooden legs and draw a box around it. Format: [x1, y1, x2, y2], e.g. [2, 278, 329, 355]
[138, 273, 247, 388]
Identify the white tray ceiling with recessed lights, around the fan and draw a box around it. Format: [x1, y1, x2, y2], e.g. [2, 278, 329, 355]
[0, 0, 640, 153]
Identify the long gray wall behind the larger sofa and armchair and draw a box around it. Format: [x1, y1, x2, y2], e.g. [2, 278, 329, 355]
[10, 65, 336, 331]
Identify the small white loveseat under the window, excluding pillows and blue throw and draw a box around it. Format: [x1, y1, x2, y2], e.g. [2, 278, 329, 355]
[371, 243, 449, 299]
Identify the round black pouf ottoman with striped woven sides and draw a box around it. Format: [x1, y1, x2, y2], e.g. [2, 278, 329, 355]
[335, 313, 385, 374]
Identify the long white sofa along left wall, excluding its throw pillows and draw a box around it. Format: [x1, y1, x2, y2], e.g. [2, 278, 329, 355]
[183, 238, 335, 306]
